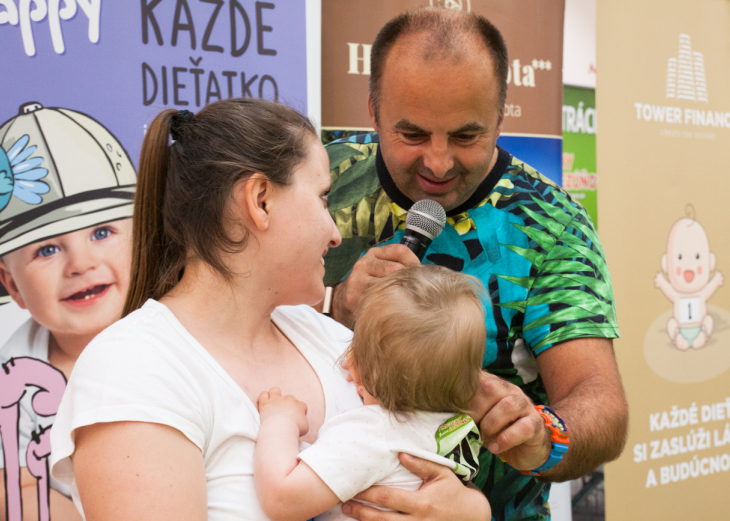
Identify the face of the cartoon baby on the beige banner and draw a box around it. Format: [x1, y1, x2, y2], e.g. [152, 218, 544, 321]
[662, 218, 715, 293]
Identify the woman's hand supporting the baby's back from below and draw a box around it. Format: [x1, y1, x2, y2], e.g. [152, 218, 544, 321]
[342, 453, 492, 521]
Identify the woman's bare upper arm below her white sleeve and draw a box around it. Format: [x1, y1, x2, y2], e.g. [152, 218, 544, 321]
[72, 422, 208, 521]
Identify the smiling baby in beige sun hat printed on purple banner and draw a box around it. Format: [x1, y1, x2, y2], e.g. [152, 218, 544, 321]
[0, 103, 137, 521]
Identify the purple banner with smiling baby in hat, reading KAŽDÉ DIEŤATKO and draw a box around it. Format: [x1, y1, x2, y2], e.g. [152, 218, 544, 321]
[0, 0, 308, 521]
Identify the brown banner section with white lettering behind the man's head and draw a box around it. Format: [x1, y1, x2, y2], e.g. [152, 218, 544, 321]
[322, 0, 565, 137]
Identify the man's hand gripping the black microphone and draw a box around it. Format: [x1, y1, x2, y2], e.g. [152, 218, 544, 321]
[332, 244, 420, 328]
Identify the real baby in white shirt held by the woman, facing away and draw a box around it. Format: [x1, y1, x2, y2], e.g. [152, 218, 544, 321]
[254, 266, 486, 521]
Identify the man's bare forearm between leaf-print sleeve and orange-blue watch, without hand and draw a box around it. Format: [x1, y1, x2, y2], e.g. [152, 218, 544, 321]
[537, 338, 629, 481]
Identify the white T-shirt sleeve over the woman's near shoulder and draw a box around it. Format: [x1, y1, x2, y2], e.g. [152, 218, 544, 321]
[53, 301, 219, 447]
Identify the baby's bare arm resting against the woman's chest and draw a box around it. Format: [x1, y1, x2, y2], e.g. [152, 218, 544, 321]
[253, 387, 340, 521]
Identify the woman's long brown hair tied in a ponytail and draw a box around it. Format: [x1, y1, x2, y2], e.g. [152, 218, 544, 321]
[122, 98, 316, 316]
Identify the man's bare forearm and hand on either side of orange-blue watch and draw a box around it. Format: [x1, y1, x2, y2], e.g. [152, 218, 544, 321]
[472, 338, 628, 481]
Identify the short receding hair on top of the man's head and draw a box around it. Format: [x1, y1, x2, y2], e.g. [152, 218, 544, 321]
[370, 8, 509, 121]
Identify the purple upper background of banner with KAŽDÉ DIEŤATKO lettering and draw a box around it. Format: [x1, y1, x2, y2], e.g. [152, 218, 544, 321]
[0, 0, 307, 169]
